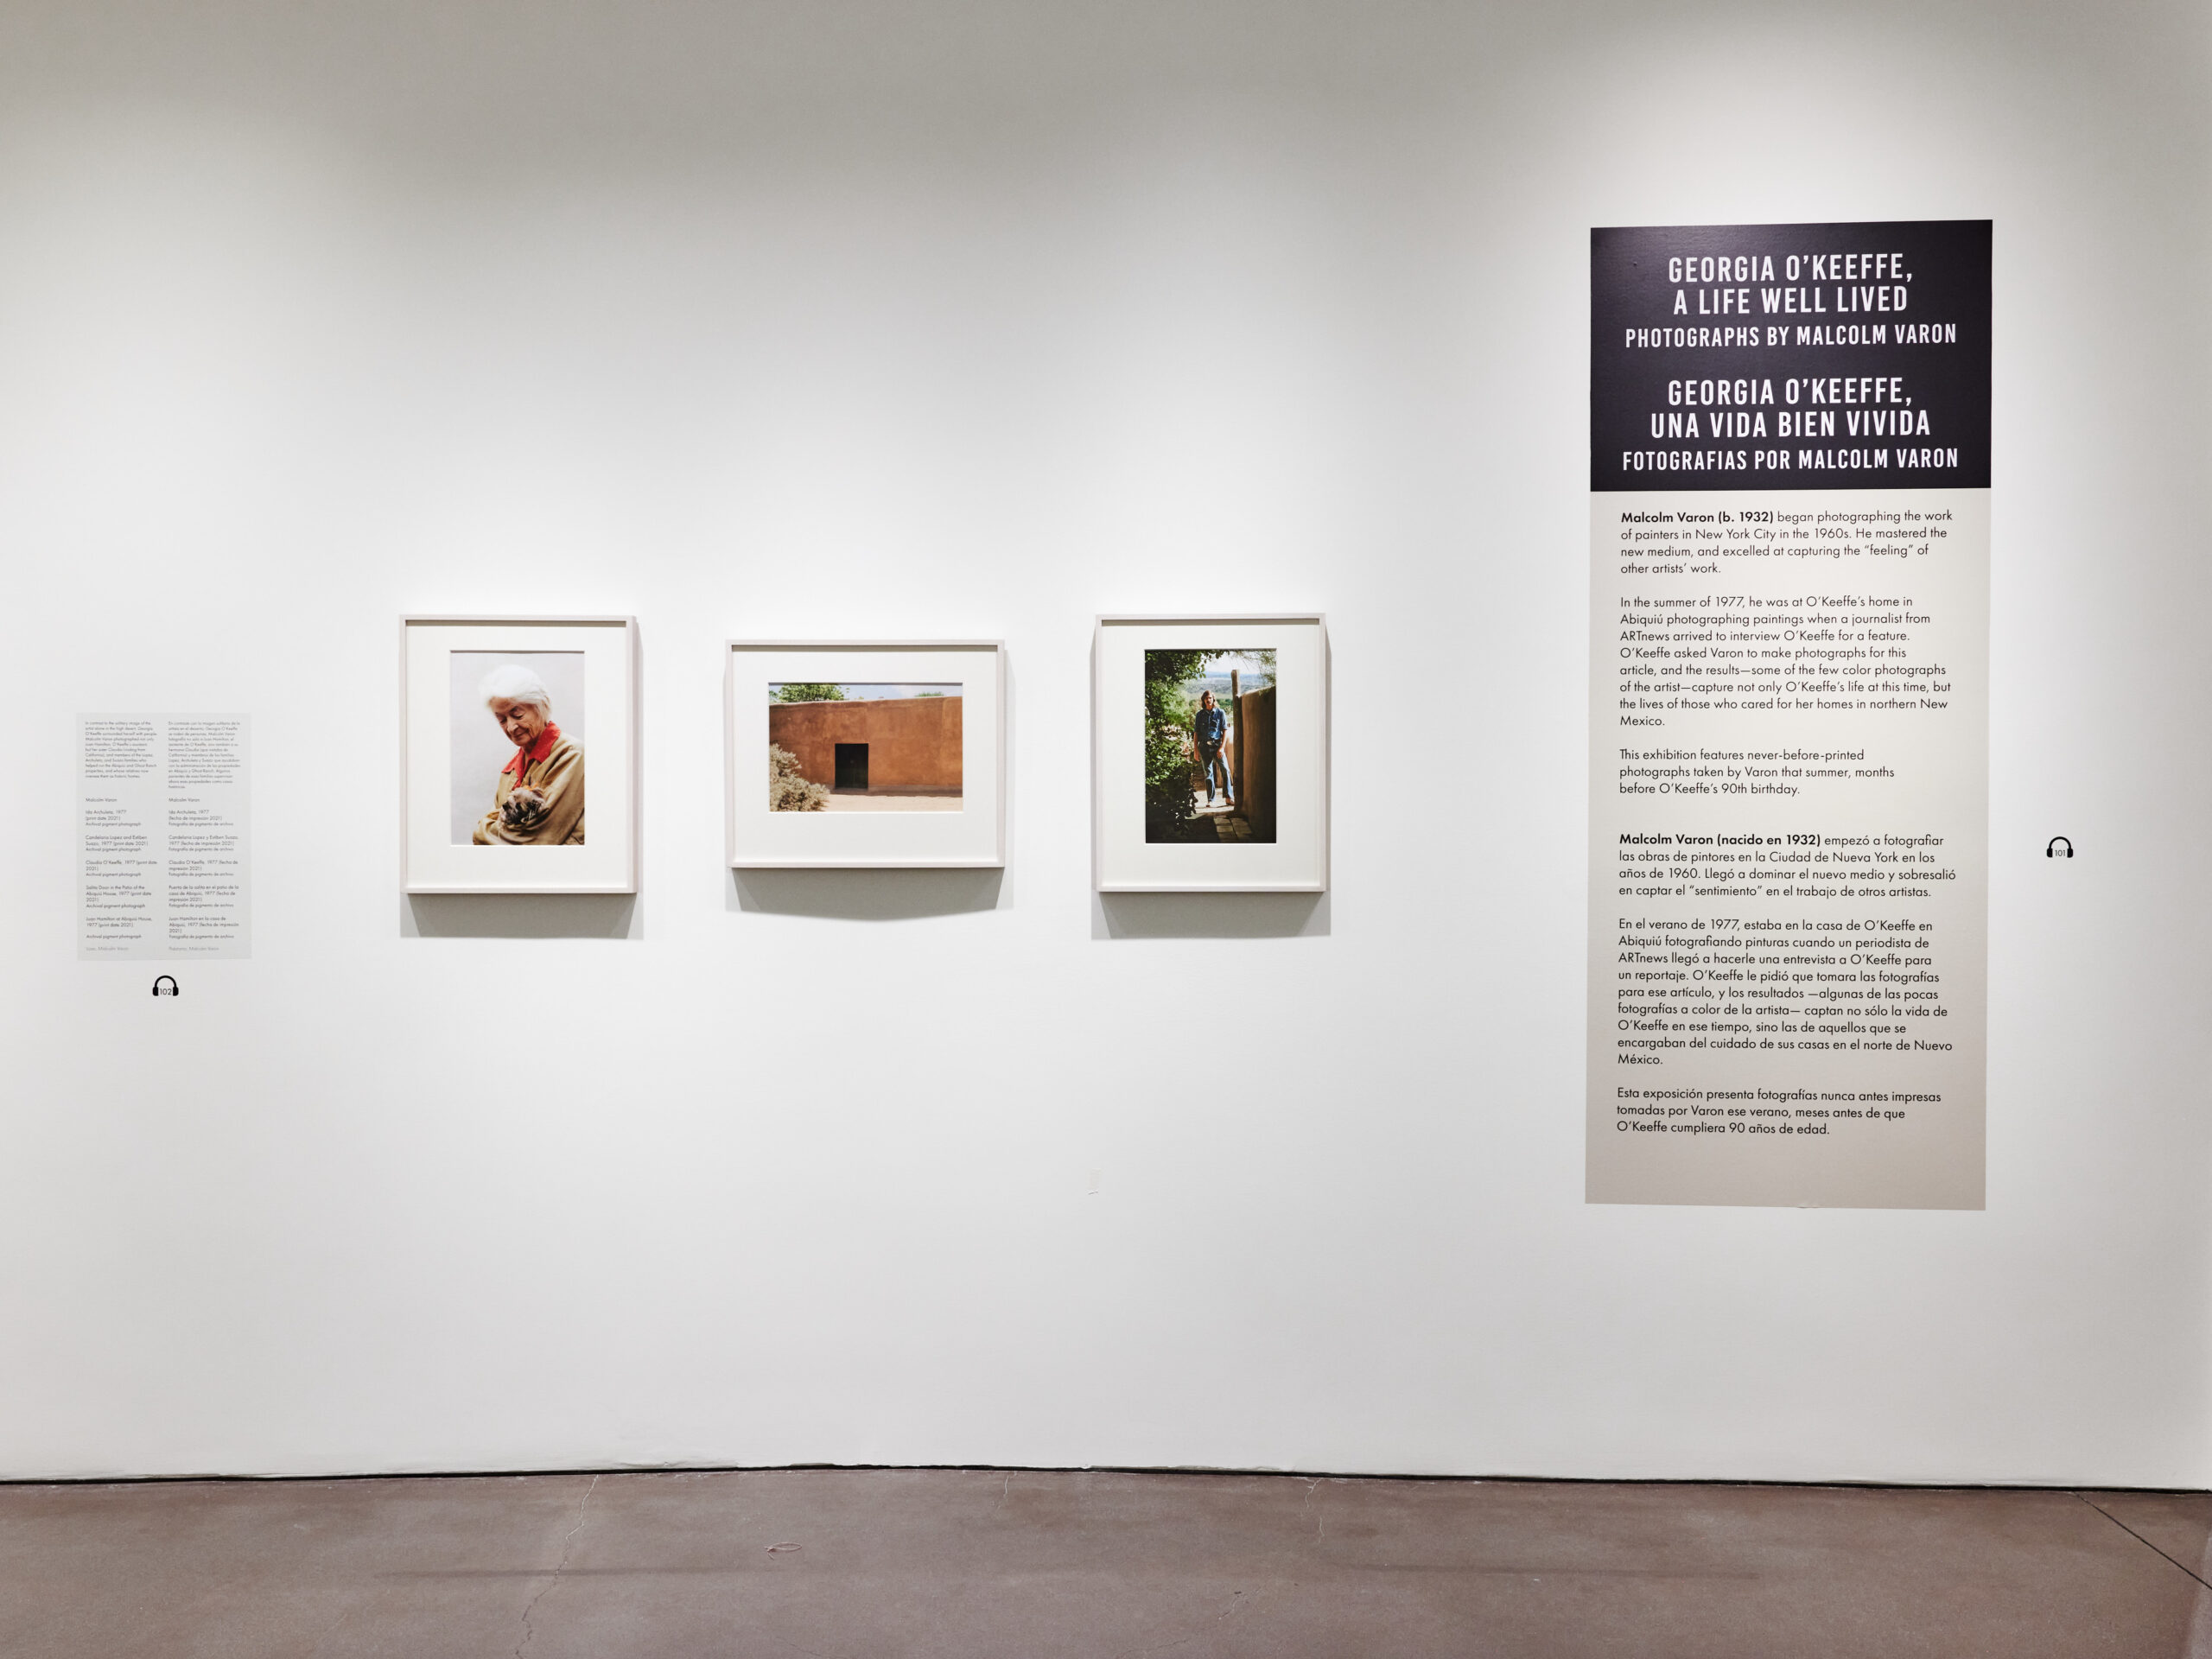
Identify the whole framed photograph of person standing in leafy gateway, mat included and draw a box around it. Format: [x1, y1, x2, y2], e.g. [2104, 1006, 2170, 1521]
[1090, 613, 1330, 893]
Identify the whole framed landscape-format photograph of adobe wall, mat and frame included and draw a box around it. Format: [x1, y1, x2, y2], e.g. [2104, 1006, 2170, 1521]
[723, 639, 1007, 869]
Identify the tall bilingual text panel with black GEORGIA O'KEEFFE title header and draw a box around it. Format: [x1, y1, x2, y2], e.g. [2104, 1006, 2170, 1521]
[1588, 221, 1988, 1208]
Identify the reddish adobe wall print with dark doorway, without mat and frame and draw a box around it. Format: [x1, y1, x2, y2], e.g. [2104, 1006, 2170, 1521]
[767, 686, 963, 812]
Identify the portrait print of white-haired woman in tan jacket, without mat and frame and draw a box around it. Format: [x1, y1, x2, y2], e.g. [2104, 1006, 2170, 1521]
[451, 651, 584, 847]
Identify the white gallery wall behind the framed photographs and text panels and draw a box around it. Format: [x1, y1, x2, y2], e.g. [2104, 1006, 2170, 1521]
[0, 0, 2212, 1486]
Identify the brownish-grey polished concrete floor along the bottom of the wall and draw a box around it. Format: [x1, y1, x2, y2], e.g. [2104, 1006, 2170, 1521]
[0, 1471, 2212, 1659]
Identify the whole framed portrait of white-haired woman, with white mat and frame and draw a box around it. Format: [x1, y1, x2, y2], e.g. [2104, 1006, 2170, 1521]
[400, 617, 639, 893]
